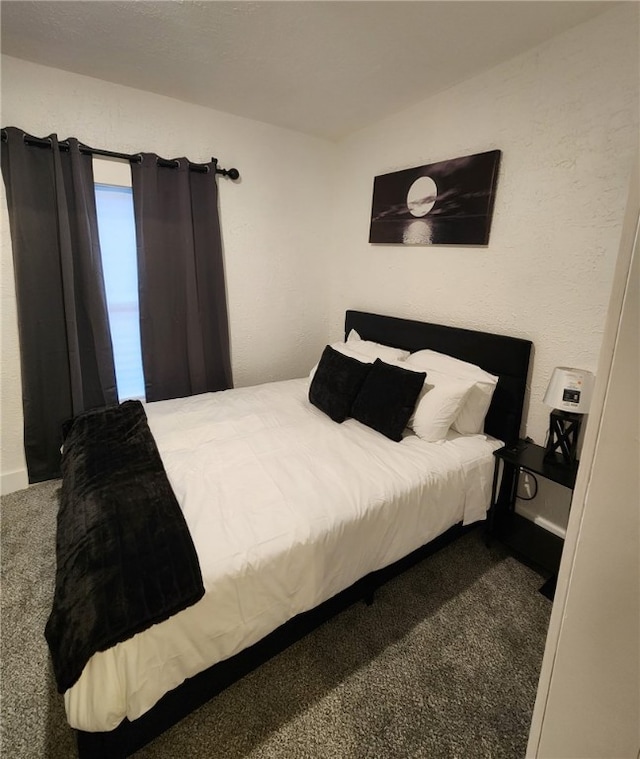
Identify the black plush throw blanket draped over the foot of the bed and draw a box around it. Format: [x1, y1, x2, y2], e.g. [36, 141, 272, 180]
[45, 401, 204, 693]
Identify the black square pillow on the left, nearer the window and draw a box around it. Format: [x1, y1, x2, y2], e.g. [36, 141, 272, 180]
[309, 345, 371, 422]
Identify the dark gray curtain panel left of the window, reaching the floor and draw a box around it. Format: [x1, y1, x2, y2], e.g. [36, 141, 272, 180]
[2, 127, 117, 482]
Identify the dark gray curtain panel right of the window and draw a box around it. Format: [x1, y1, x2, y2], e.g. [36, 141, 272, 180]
[131, 153, 232, 401]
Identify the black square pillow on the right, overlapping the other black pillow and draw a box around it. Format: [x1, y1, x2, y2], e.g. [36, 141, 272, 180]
[351, 358, 427, 442]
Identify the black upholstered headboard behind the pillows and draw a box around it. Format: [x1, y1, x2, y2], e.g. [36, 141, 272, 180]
[345, 311, 532, 444]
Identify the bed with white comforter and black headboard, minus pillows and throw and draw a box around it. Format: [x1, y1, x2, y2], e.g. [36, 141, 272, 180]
[48, 311, 531, 757]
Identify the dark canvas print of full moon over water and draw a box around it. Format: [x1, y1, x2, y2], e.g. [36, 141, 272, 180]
[369, 150, 501, 245]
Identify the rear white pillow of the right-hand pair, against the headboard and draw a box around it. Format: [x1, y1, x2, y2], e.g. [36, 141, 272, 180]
[406, 350, 498, 435]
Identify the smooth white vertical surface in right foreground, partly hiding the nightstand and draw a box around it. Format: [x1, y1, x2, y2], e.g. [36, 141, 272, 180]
[527, 164, 640, 759]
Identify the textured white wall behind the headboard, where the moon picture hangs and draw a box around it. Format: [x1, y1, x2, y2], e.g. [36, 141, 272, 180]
[329, 3, 639, 526]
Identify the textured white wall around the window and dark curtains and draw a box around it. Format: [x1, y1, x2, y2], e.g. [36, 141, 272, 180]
[0, 56, 335, 492]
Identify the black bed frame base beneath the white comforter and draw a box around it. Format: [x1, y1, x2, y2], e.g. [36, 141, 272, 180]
[75, 524, 476, 759]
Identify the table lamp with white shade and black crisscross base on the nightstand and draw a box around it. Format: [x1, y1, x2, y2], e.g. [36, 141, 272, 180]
[543, 366, 594, 465]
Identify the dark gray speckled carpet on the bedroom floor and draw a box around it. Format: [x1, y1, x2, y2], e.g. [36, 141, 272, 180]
[0, 482, 551, 759]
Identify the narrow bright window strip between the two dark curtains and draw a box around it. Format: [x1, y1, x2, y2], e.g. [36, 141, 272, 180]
[94, 159, 145, 401]
